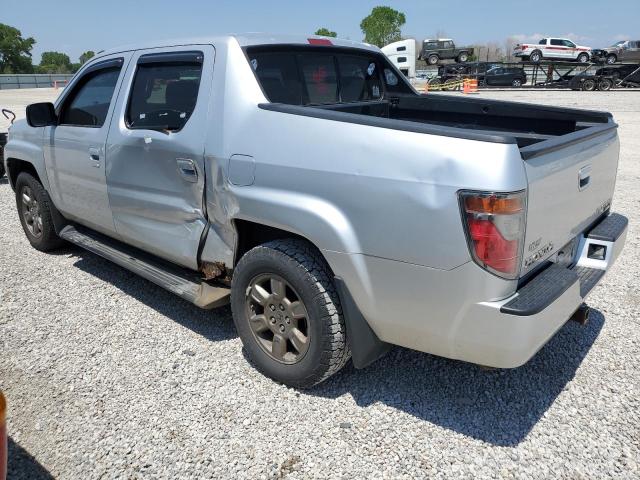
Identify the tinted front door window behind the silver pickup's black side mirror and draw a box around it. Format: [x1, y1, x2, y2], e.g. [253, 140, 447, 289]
[60, 67, 120, 127]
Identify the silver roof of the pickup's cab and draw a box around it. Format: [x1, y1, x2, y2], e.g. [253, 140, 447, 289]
[97, 33, 378, 57]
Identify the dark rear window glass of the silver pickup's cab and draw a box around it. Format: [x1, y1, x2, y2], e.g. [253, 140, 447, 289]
[247, 50, 383, 105]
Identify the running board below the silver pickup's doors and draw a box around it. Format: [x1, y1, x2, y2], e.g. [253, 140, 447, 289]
[60, 225, 230, 309]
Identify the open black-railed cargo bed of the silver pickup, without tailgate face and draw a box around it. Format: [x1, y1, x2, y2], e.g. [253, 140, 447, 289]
[260, 95, 616, 157]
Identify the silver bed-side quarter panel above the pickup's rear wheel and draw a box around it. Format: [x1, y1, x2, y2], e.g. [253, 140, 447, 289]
[207, 39, 526, 269]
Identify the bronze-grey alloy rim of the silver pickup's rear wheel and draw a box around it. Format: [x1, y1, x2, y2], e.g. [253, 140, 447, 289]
[245, 273, 310, 365]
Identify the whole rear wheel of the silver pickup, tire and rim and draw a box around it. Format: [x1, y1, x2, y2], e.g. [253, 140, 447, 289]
[231, 239, 351, 388]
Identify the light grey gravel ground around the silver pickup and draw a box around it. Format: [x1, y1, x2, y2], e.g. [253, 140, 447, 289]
[0, 91, 640, 479]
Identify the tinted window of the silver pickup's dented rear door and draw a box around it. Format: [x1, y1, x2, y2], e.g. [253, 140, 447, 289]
[126, 52, 202, 131]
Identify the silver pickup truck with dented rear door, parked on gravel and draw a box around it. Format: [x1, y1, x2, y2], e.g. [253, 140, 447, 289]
[5, 35, 627, 387]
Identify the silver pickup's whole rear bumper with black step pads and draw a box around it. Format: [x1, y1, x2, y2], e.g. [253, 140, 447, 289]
[323, 214, 627, 368]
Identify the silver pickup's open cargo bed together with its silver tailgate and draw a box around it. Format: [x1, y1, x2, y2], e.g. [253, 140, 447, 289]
[261, 95, 619, 276]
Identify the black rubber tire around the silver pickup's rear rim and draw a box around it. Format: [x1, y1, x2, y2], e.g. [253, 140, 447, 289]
[231, 239, 351, 388]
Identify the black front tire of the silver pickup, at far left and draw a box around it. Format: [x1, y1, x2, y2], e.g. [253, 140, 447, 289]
[16, 172, 64, 252]
